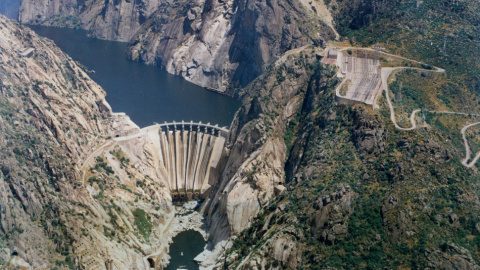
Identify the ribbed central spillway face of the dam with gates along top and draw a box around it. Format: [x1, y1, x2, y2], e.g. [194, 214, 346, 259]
[147, 122, 229, 201]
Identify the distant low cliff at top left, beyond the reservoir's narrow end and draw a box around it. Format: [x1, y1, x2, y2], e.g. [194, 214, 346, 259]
[19, 0, 163, 42]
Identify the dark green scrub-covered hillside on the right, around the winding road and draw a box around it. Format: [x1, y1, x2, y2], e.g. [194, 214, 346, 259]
[224, 1, 480, 269]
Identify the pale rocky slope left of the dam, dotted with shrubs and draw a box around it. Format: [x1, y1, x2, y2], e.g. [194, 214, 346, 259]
[0, 16, 178, 269]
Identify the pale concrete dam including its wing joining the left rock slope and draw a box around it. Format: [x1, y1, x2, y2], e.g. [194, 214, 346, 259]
[108, 121, 230, 202]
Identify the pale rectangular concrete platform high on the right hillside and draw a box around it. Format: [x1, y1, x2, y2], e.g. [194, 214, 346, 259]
[336, 50, 382, 109]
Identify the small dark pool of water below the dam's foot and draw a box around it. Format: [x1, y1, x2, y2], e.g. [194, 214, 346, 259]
[166, 230, 205, 270]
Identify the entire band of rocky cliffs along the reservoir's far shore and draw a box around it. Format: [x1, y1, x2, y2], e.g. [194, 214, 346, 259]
[19, 0, 338, 92]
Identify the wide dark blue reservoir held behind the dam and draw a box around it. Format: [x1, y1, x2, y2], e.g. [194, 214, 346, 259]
[29, 25, 240, 127]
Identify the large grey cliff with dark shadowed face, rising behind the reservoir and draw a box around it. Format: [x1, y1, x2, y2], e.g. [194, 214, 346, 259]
[129, 0, 335, 92]
